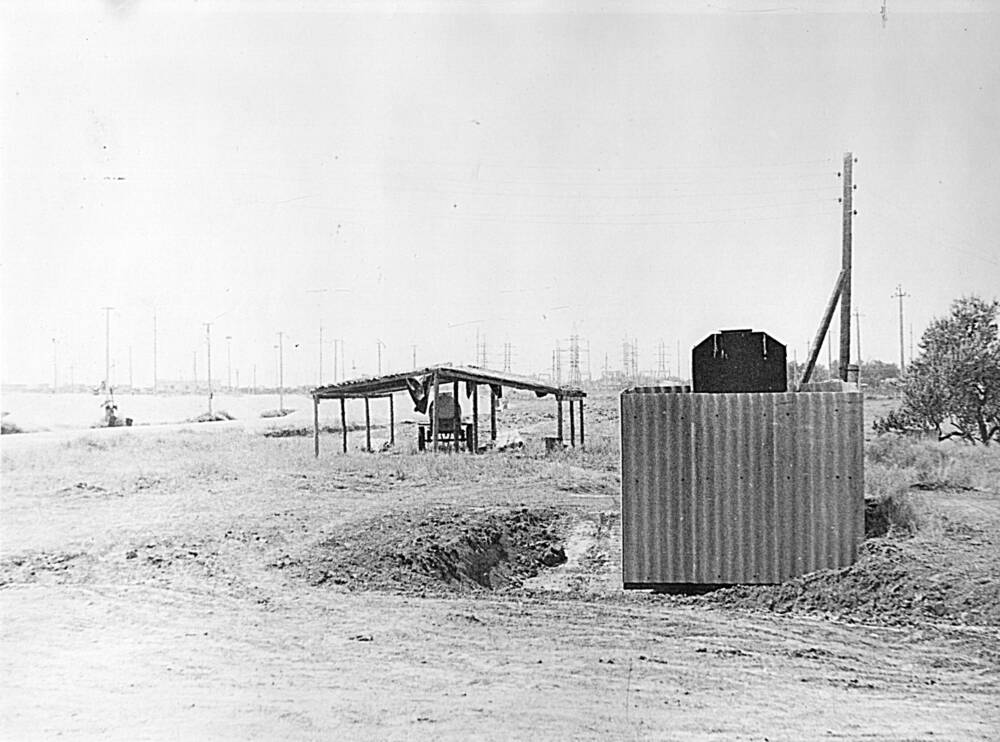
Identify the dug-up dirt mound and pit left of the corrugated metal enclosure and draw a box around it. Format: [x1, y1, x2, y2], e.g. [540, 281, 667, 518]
[292, 508, 566, 592]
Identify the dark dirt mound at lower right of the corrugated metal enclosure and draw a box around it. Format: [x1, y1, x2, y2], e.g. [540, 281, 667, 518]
[686, 524, 1000, 626]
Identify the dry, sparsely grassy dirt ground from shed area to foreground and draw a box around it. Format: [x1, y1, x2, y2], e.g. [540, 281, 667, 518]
[0, 400, 1000, 740]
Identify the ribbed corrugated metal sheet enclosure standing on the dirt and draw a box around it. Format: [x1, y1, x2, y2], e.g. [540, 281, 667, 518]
[621, 390, 864, 587]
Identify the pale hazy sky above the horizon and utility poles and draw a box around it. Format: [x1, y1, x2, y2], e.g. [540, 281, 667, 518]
[0, 0, 1000, 392]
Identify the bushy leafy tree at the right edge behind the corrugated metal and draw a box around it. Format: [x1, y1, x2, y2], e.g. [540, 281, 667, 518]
[903, 296, 1000, 445]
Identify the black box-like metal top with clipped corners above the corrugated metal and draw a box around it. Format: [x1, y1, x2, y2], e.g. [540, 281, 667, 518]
[691, 330, 788, 392]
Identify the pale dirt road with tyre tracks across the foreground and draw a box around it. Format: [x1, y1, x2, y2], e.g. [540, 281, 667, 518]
[0, 585, 1000, 740]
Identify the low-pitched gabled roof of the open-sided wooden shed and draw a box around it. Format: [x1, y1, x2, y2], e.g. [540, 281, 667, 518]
[311, 363, 587, 399]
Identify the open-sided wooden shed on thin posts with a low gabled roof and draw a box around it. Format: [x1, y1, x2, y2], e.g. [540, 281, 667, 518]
[312, 364, 587, 456]
